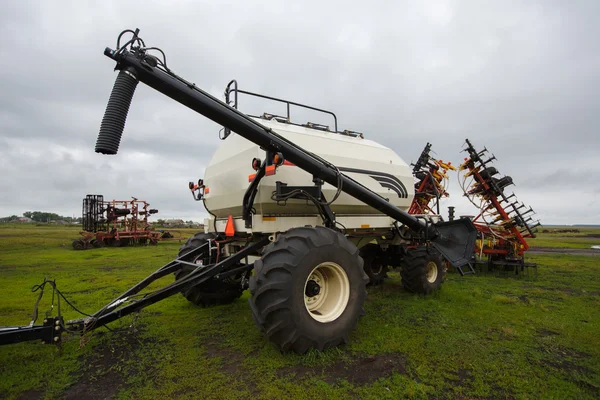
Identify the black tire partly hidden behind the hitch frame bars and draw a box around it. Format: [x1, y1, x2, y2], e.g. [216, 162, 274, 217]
[175, 233, 243, 307]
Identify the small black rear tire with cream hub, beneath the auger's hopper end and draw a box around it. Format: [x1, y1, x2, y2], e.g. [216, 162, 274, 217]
[400, 247, 446, 294]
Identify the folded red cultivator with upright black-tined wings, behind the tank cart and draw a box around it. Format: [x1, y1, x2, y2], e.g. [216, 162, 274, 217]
[409, 139, 540, 275]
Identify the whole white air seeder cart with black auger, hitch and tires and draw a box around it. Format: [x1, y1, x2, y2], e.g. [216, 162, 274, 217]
[0, 30, 477, 353]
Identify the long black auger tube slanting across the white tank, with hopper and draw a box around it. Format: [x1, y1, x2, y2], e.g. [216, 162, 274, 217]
[96, 36, 476, 266]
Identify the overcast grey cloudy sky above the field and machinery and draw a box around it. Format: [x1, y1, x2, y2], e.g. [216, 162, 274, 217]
[0, 0, 600, 224]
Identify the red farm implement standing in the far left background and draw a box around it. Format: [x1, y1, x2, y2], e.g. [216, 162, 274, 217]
[73, 194, 172, 250]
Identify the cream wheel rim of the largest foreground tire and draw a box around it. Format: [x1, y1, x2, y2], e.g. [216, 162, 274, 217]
[303, 262, 350, 323]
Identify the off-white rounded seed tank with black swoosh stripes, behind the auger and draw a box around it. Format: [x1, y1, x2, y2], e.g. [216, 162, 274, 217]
[204, 118, 414, 230]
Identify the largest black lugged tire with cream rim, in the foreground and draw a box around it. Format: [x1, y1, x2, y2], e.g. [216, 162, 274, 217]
[249, 227, 369, 354]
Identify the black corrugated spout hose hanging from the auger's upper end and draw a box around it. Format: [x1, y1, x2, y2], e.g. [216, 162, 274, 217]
[96, 69, 138, 154]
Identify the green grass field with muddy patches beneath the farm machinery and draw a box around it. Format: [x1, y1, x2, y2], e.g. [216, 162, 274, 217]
[0, 225, 600, 400]
